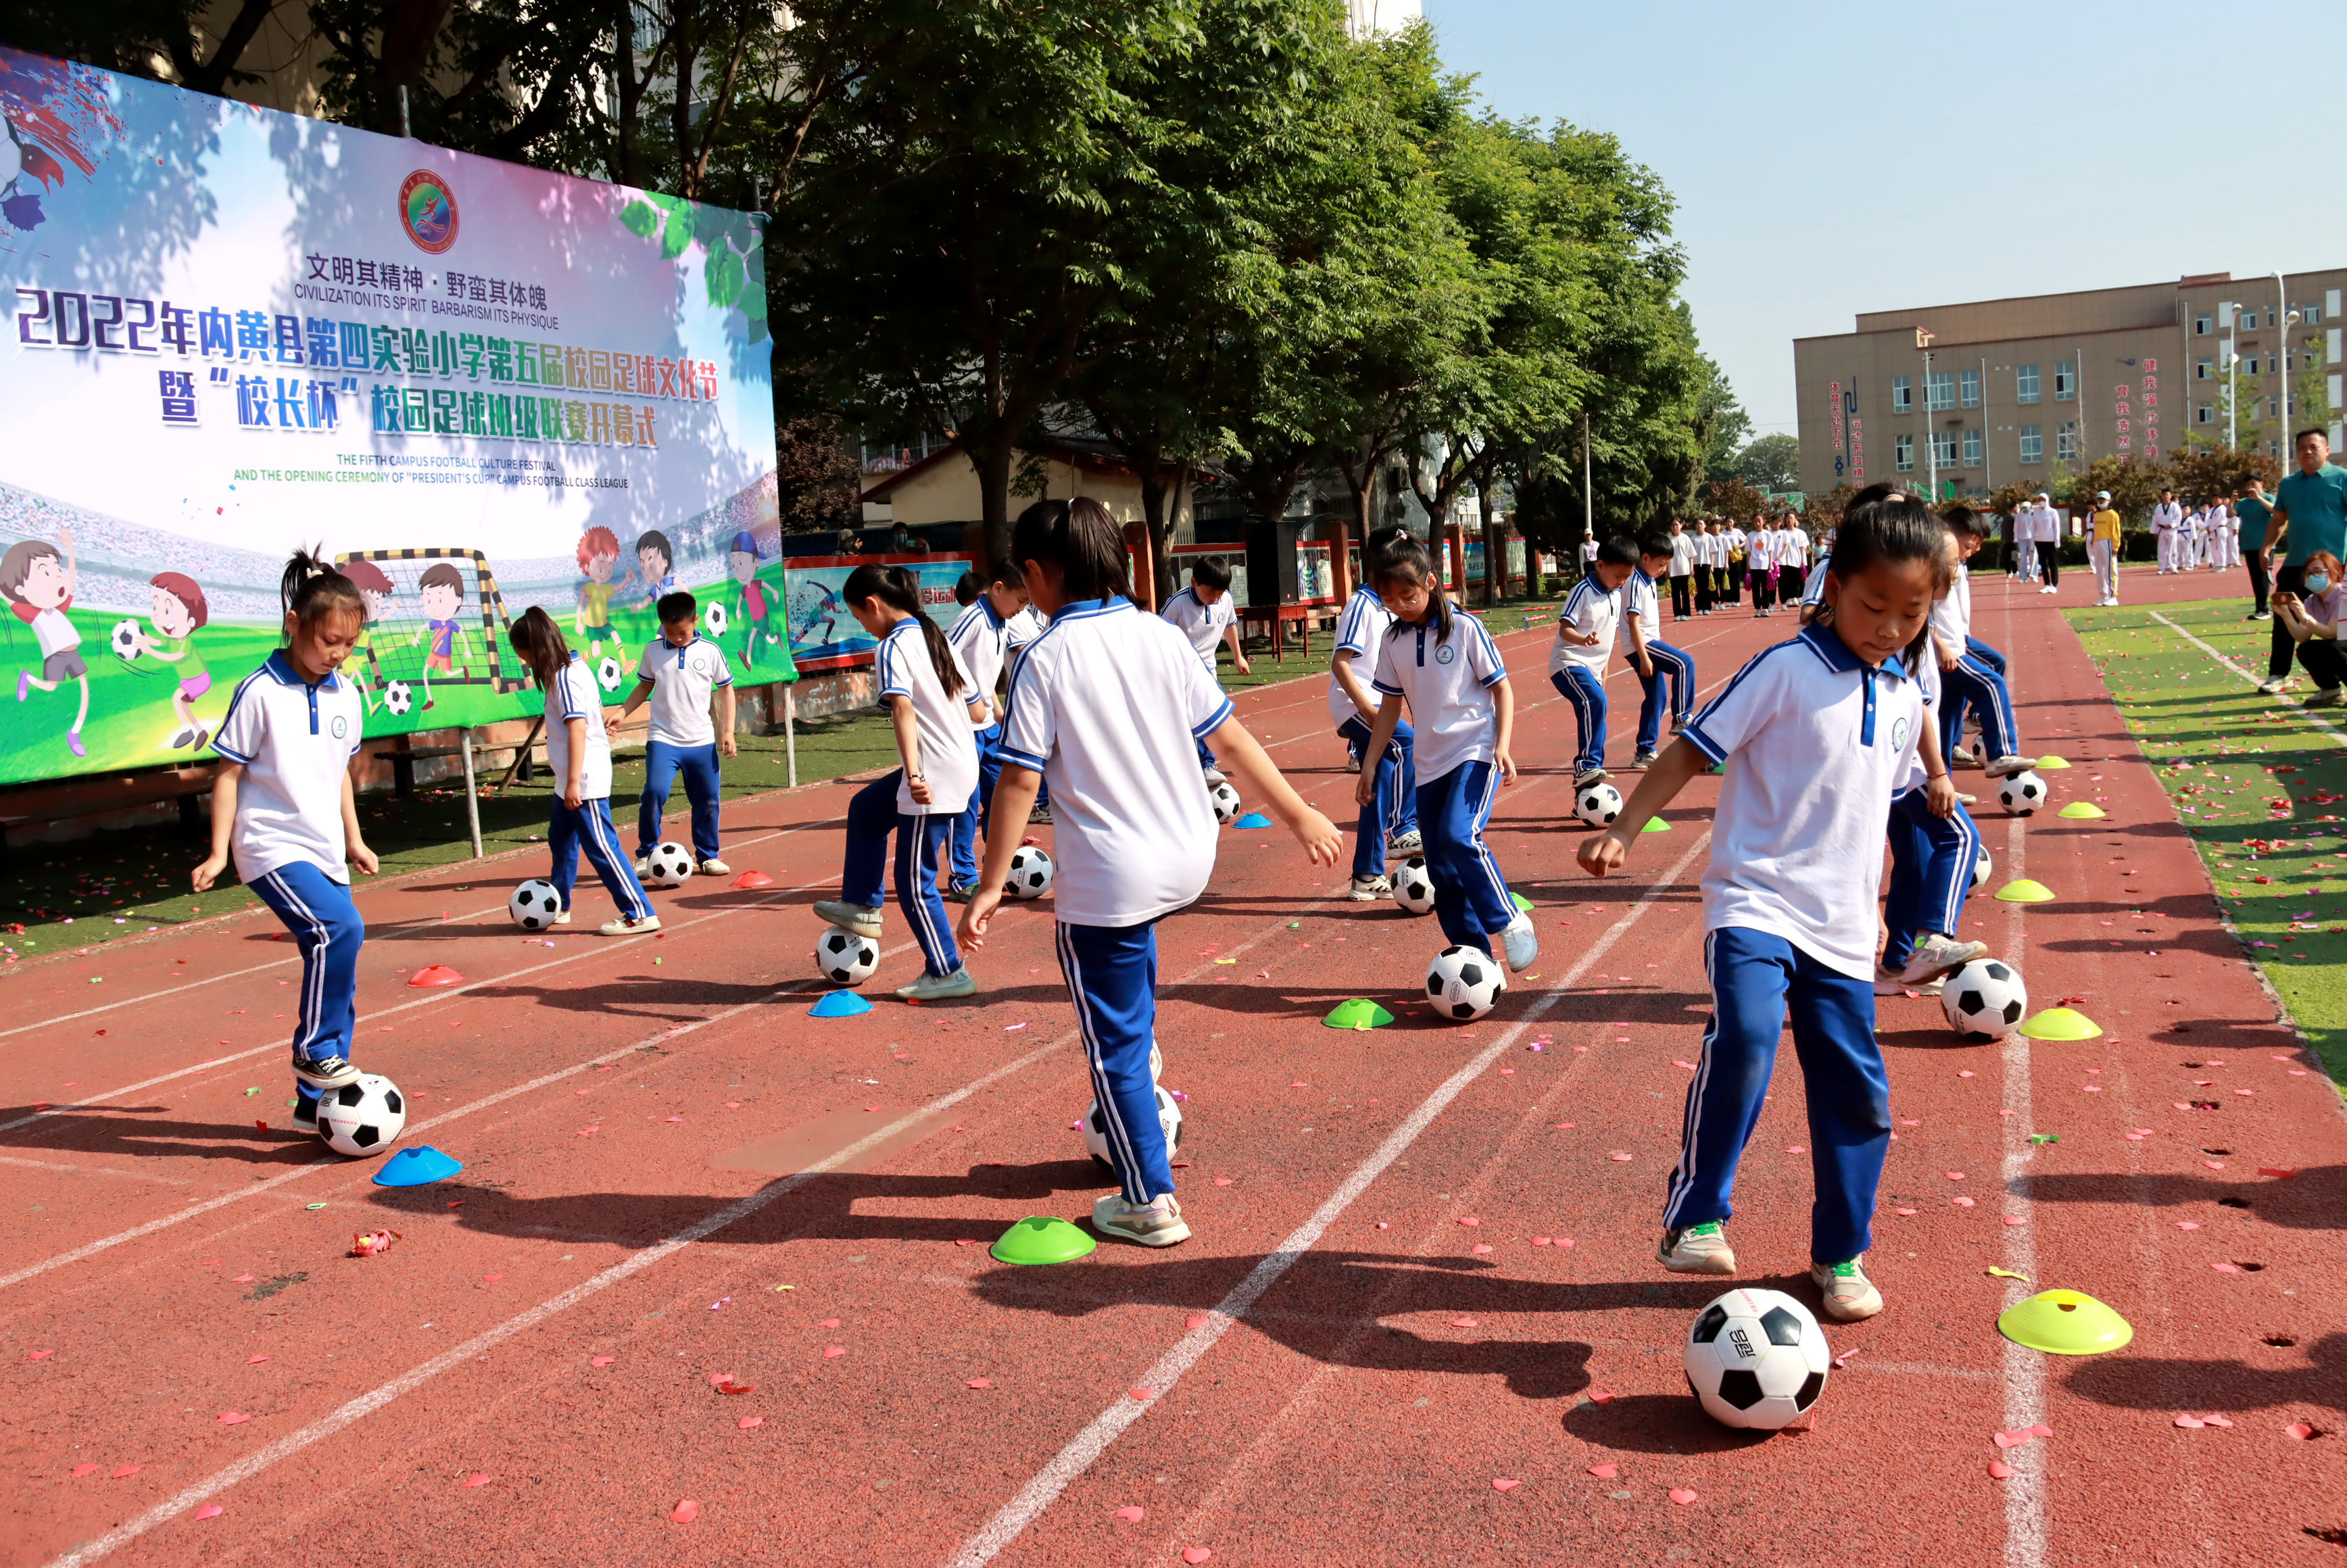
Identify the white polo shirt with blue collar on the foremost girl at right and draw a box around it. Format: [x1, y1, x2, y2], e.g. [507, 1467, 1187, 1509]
[1683, 627, 1925, 981]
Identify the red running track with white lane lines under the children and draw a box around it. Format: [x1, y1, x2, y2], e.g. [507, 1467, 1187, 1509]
[0, 577, 2347, 1566]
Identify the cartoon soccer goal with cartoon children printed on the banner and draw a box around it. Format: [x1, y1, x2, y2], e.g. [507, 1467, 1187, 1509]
[335, 549, 531, 718]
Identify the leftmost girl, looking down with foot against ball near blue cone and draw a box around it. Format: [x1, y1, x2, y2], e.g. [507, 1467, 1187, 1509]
[195, 547, 376, 1131]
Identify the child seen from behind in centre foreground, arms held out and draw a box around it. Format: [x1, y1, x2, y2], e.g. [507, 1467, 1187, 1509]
[963, 500, 1345, 1246]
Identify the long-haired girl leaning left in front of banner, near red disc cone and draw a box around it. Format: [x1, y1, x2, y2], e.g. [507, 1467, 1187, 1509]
[507, 606, 660, 937]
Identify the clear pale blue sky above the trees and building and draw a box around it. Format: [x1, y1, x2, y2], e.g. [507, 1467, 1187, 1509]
[1425, 0, 2347, 435]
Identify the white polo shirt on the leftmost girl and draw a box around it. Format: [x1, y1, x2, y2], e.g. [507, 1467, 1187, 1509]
[211, 648, 364, 883]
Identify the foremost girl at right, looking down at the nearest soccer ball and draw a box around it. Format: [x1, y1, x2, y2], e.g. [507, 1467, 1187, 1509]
[1580, 491, 1948, 1321]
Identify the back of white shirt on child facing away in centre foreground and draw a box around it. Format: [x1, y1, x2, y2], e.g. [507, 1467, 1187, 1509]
[1002, 596, 1230, 925]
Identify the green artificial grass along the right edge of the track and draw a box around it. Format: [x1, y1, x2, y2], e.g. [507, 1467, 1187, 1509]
[2065, 599, 2347, 1085]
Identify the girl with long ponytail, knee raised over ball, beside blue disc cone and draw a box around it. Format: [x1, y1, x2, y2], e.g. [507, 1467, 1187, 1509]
[815, 561, 986, 1002]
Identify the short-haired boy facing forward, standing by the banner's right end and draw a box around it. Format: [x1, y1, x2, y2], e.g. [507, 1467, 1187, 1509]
[620, 589, 742, 875]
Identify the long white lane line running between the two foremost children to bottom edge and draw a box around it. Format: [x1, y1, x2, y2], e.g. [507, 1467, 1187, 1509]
[946, 831, 1711, 1568]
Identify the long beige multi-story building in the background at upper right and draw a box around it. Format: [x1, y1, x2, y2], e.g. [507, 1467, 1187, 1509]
[1793, 268, 2347, 495]
